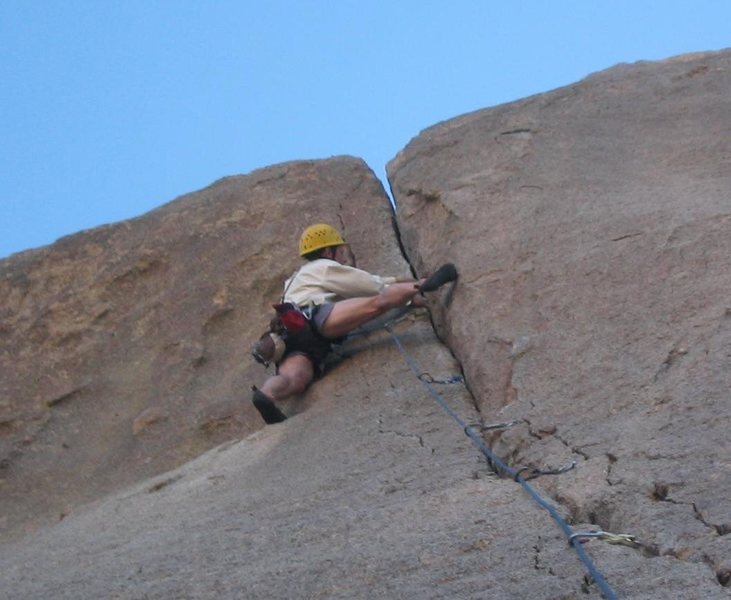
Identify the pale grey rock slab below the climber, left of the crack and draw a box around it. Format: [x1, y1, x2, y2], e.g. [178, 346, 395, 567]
[0, 319, 604, 600]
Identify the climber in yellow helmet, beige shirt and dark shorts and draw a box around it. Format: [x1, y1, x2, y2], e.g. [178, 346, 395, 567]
[252, 223, 457, 423]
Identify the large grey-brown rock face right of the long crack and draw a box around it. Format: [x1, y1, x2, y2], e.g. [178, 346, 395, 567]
[388, 51, 731, 598]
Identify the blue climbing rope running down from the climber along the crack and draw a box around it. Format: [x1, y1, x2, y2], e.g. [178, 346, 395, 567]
[385, 324, 617, 600]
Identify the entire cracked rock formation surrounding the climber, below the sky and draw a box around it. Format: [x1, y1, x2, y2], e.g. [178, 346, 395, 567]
[0, 52, 731, 599]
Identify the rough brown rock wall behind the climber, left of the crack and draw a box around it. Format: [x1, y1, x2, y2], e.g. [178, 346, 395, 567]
[0, 158, 409, 537]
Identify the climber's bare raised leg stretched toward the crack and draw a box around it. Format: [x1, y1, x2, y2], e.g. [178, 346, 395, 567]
[320, 281, 419, 339]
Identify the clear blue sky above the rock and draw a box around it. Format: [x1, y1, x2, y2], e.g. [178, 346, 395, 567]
[0, 0, 731, 257]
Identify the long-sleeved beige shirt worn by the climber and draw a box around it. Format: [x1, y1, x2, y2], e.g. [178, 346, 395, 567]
[284, 258, 396, 306]
